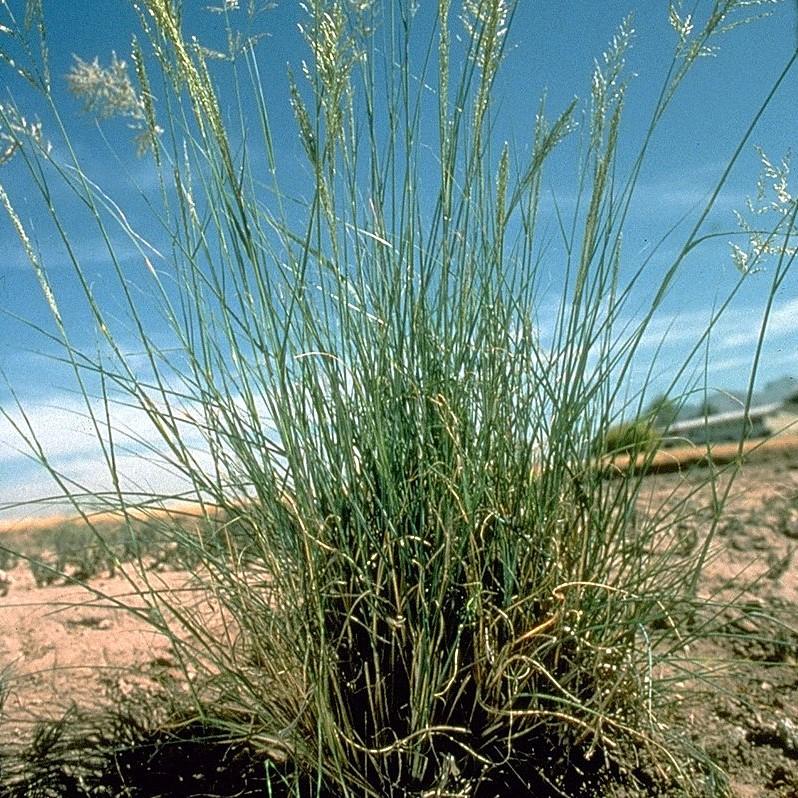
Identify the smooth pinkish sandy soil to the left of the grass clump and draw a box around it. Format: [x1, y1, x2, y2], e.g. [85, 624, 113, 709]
[0, 564, 189, 740]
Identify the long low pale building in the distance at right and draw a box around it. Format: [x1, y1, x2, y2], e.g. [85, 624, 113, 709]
[663, 377, 798, 446]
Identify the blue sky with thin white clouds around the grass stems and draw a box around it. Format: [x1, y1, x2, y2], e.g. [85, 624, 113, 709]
[0, 0, 798, 519]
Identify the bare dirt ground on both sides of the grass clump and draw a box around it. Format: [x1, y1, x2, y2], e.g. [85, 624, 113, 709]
[0, 446, 798, 798]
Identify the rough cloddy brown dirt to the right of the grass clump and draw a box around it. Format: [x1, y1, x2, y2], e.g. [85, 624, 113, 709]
[644, 447, 798, 798]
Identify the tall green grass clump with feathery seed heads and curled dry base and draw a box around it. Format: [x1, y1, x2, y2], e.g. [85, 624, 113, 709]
[0, 0, 795, 798]
